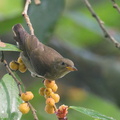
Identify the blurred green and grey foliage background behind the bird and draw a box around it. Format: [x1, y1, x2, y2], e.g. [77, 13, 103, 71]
[0, 0, 120, 120]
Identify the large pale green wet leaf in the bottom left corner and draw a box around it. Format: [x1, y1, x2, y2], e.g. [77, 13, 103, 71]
[0, 74, 22, 120]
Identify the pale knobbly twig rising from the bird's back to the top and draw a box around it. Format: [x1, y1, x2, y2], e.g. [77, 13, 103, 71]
[22, 0, 34, 35]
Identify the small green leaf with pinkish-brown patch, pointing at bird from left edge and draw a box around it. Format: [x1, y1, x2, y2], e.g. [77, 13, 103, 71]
[0, 42, 21, 52]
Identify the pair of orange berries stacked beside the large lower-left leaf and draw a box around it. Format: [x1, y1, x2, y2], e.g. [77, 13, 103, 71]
[19, 91, 34, 114]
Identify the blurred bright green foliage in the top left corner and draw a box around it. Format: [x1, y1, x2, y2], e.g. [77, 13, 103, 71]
[0, 0, 23, 34]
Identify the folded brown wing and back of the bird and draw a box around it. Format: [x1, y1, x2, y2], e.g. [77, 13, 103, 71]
[26, 38, 62, 76]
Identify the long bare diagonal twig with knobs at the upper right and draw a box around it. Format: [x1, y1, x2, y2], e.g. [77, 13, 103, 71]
[84, 0, 120, 48]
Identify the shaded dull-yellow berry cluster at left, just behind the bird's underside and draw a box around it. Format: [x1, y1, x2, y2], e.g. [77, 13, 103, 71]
[9, 57, 27, 73]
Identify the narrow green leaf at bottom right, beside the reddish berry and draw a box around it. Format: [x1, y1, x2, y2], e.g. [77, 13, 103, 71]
[69, 106, 115, 120]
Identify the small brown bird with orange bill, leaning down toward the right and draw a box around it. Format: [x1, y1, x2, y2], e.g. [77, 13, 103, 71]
[12, 24, 77, 80]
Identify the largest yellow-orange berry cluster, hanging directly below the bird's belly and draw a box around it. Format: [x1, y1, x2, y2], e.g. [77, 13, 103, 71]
[39, 80, 60, 114]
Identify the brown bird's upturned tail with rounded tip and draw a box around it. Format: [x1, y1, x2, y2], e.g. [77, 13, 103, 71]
[12, 24, 29, 50]
